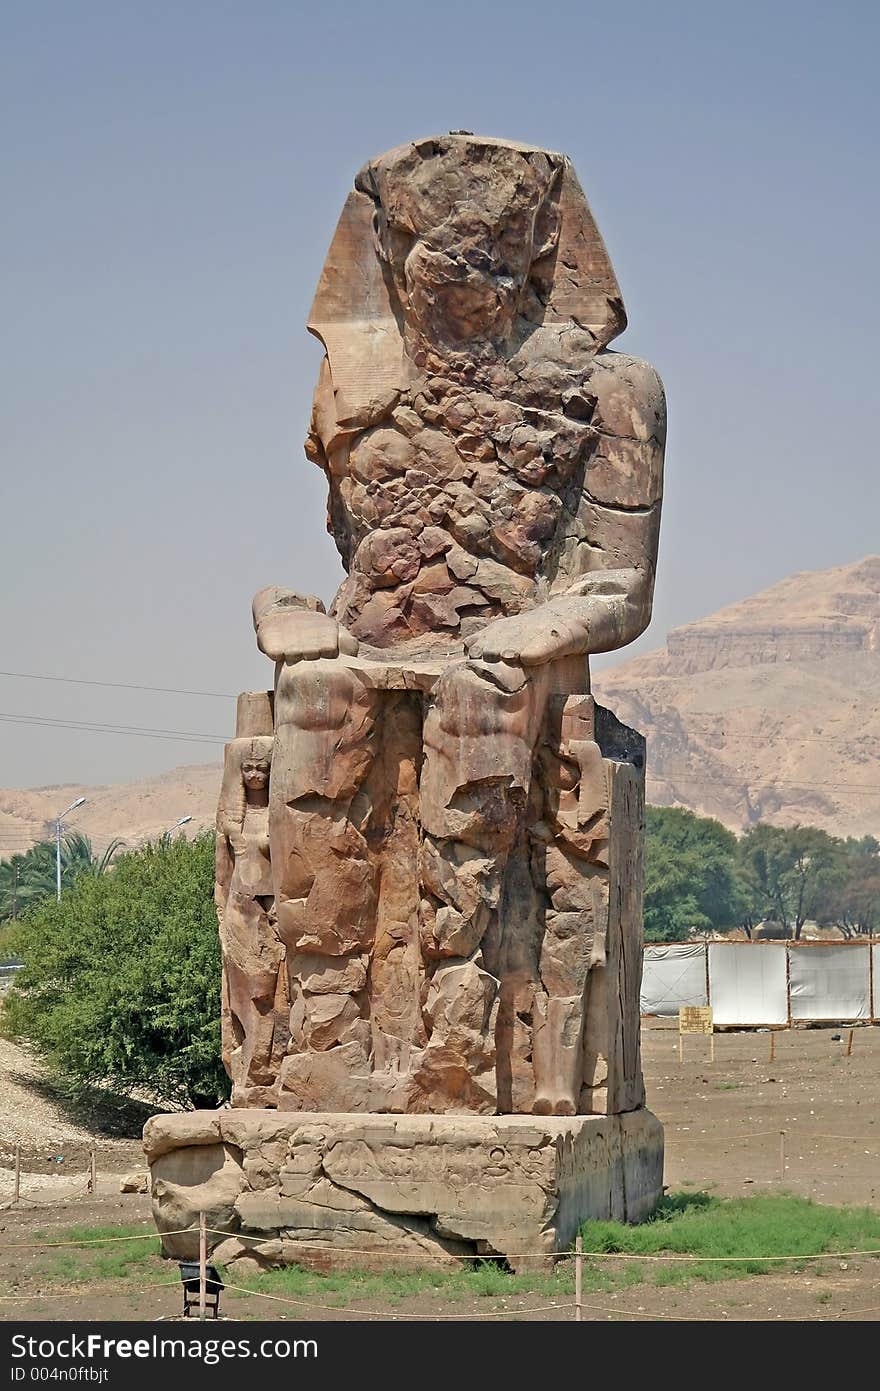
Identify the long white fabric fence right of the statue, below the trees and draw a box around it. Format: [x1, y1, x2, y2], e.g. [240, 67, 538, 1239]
[641, 942, 880, 1028]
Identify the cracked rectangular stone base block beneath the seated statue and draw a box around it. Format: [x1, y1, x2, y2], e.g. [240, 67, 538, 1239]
[145, 1109, 663, 1270]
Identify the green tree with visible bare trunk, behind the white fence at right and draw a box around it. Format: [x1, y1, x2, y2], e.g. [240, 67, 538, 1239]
[740, 822, 845, 942]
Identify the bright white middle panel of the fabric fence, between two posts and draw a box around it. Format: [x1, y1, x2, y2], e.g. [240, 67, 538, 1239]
[709, 942, 788, 1027]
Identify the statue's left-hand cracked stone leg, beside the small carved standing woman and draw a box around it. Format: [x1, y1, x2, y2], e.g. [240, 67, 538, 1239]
[268, 661, 377, 1068]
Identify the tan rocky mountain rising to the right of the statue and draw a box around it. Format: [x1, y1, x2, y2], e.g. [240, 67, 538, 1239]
[594, 555, 880, 835]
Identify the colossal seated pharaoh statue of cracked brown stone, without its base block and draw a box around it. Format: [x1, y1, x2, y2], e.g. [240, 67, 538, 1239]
[218, 132, 666, 1116]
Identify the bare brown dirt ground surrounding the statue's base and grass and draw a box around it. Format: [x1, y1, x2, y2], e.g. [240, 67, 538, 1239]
[0, 1020, 880, 1321]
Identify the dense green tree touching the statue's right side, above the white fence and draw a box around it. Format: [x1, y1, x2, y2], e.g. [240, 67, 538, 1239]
[645, 807, 745, 942]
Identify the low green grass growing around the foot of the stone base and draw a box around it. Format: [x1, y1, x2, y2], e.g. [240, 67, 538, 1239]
[8, 1191, 880, 1317]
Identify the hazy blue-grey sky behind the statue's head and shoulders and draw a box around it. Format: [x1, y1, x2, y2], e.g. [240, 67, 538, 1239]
[0, 0, 880, 786]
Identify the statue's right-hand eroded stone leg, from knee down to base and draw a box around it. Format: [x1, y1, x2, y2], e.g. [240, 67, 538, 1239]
[420, 662, 548, 1110]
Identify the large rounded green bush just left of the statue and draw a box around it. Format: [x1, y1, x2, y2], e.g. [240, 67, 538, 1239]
[4, 833, 228, 1106]
